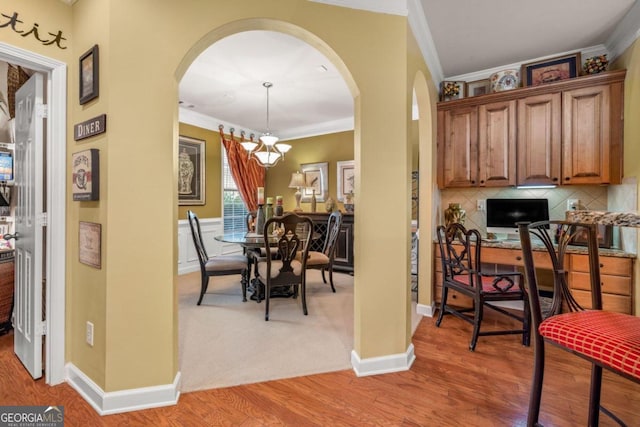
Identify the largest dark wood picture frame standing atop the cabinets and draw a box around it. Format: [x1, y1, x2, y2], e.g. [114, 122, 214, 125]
[520, 52, 582, 87]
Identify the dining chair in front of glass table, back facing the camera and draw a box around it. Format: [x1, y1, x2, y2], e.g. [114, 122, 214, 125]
[257, 213, 313, 321]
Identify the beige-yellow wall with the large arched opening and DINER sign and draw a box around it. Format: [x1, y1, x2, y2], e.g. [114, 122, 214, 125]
[0, 0, 422, 392]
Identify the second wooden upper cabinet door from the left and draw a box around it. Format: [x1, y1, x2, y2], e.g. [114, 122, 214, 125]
[478, 101, 516, 187]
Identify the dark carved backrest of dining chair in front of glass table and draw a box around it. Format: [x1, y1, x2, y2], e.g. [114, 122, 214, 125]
[264, 213, 313, 284]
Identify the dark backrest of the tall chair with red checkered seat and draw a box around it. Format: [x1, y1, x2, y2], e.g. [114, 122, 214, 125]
[518, 221, 602, 328]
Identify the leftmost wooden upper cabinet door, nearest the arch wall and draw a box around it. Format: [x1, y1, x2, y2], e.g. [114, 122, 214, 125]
[438, 107, 478, 188]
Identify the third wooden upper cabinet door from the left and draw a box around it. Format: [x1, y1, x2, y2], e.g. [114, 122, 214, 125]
[517, 93, 561, 185]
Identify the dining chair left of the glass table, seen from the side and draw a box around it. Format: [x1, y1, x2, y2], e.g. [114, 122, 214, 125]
[187, 211, 249, 305]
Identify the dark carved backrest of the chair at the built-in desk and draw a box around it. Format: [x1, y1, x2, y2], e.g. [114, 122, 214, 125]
[436, 222, 482, 289]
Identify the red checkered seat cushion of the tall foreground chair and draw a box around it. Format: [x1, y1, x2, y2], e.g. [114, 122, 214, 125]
[538, 310, 640, 379]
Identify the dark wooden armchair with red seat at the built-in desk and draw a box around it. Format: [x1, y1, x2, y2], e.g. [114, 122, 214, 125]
[436, 223, 529, 351]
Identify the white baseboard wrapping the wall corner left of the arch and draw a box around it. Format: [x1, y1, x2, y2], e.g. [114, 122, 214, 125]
[66, 363, 180, 415]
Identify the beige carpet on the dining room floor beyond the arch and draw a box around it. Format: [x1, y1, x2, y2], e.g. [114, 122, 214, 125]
[178, 270, 420, 392]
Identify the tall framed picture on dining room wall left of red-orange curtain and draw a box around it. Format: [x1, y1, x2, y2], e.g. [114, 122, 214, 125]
[178, 135, 205, 205]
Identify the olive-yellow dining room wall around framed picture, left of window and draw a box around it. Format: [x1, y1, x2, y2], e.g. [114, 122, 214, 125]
[178, 123, 222, 219]
